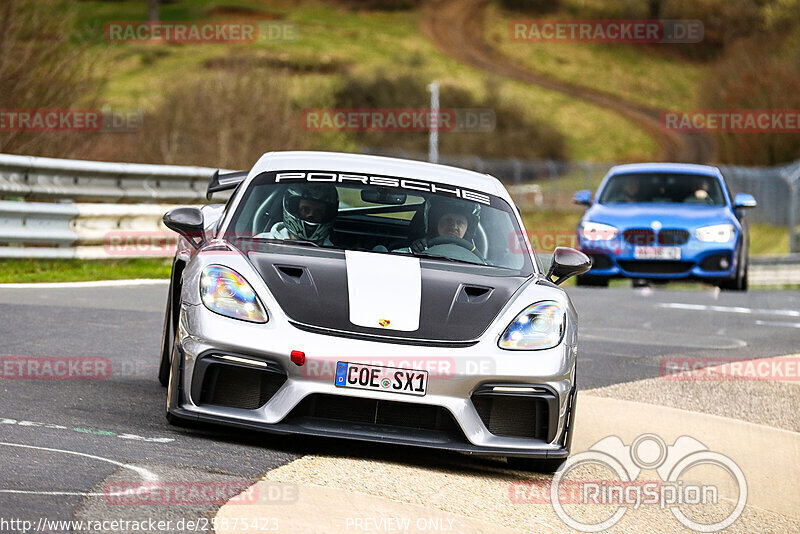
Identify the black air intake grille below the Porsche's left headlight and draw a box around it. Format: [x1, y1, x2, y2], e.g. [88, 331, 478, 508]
[200, 363, 286, 410]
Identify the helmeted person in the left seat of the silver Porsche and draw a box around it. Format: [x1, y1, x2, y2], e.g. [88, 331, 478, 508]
[256, 184, 339, 246]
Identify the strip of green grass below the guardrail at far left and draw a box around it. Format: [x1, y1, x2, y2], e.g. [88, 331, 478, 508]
[0, 258, 172, 283]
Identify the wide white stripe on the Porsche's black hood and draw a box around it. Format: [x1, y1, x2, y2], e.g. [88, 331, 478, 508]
[345, 250, 422, 332]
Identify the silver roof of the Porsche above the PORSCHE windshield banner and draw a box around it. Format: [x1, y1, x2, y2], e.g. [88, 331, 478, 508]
[247, 150, 511, 202]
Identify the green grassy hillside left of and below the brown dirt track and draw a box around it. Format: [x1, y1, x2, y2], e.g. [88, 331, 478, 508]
[69, 0, 658, 161]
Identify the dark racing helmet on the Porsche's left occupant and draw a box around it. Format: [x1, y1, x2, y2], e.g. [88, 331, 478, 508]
[283, 184, 339, 243]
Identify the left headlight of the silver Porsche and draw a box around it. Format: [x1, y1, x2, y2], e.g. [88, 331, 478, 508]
[200, 265, 267, 323]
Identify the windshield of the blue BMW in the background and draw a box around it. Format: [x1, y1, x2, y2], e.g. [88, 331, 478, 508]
[599, 173, 725, 206]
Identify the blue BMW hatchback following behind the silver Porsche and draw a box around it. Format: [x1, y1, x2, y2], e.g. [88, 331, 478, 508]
[574, 163, 756, 291]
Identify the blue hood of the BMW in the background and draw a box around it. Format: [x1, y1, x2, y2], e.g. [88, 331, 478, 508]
[584, 204, 733, 229]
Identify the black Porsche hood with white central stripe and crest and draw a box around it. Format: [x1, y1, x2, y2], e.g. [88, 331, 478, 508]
[247, 246, 529, 342]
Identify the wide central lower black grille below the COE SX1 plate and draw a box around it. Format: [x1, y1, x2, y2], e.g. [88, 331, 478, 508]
[287, 393, 459, 431]
